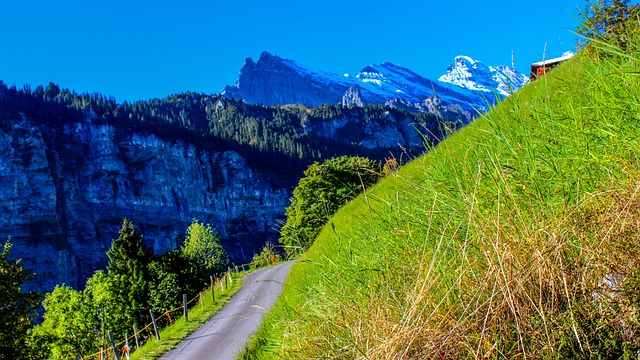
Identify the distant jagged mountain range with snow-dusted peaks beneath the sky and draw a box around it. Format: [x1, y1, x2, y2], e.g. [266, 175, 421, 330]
[222, 51, 527, 123]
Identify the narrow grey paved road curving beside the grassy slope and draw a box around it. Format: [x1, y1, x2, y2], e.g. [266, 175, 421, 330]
[160, 261, 293, 360]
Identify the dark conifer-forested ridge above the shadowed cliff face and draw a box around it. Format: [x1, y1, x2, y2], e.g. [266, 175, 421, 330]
[0, 82, 443, 179]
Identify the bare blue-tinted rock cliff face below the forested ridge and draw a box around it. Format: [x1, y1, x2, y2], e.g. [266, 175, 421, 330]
[0, 112, 291, 290]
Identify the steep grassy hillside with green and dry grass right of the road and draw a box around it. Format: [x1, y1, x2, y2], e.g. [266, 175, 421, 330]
[245, 32, 640, 359]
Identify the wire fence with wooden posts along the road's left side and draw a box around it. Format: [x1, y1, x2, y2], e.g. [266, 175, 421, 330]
[82, 264, 251, 360]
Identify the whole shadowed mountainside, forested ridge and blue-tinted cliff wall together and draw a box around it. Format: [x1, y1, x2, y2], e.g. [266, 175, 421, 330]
[0, 81, 448, 291]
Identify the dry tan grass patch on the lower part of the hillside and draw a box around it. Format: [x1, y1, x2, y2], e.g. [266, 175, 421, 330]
[301, 179, 640, 359]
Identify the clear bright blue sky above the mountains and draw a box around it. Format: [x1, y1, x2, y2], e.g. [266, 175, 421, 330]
[0, 0, 596, 102]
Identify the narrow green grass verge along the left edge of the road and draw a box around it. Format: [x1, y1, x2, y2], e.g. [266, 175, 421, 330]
[125, 272, 248, 360]
